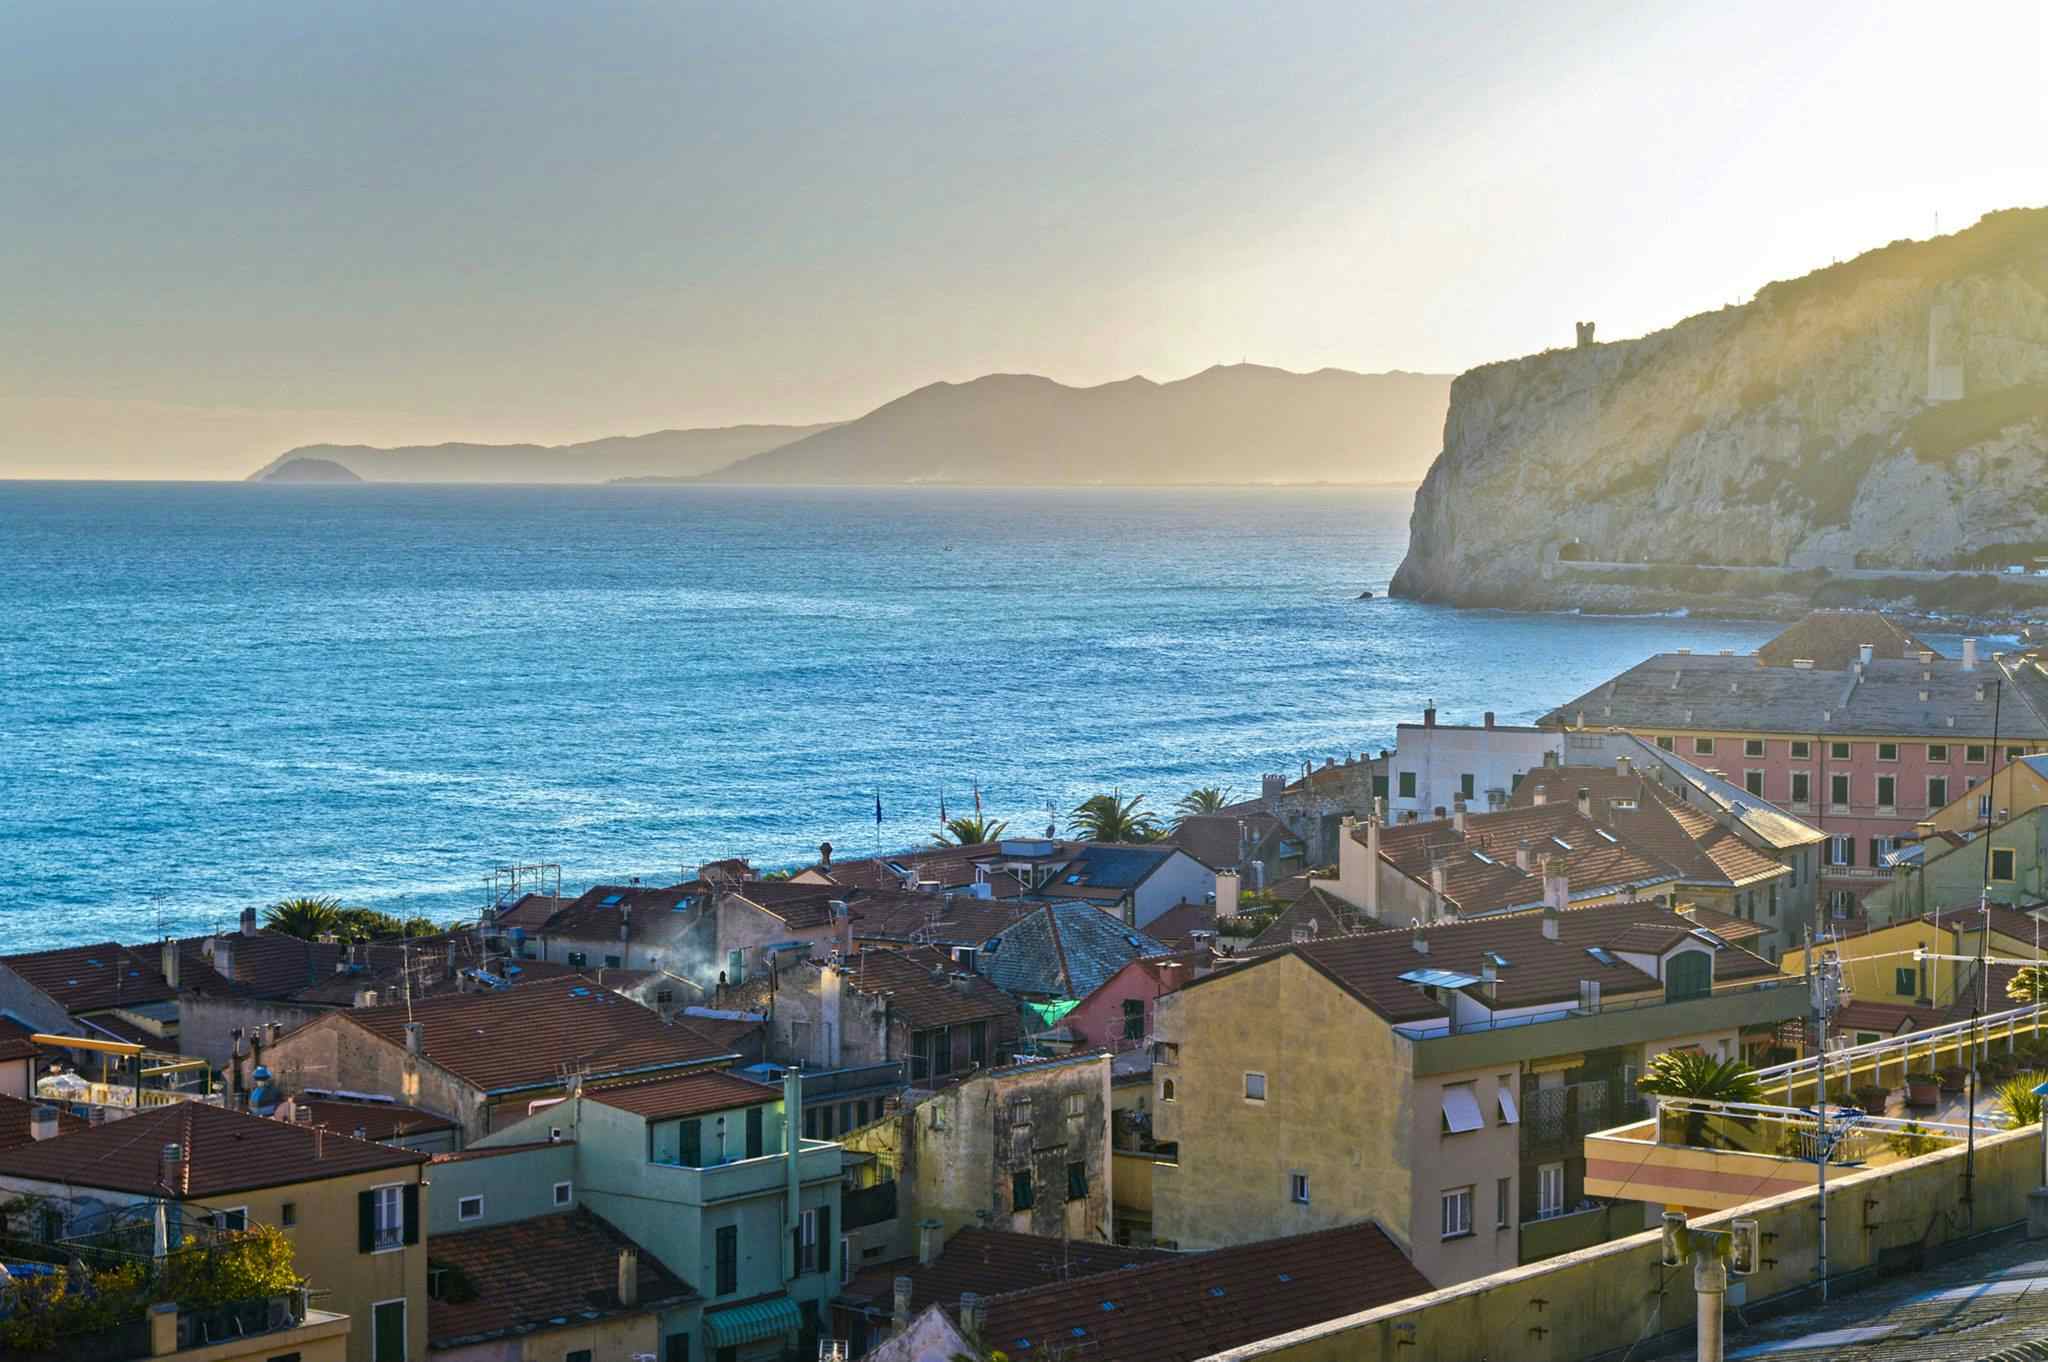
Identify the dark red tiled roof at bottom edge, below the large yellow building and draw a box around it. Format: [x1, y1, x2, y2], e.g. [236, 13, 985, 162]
[981, 1221, 1430, 1362]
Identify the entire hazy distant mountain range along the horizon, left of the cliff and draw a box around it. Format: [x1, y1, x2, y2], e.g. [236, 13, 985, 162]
[252, 365, 1450, 485]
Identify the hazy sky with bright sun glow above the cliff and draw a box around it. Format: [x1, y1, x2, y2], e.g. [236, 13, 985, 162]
[0, 0, 2048, 477]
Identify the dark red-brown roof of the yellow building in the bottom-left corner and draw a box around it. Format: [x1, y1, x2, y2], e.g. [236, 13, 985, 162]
[0, 1102, 426, 1200]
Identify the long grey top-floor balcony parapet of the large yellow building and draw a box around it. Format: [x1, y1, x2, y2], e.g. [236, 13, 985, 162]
[1395, 975, 1806, 1077]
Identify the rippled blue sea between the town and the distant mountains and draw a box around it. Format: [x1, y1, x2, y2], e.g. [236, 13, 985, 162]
[0, 483, 1776, 950]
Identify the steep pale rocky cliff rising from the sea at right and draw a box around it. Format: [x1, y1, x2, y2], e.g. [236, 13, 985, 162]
[1393, 209, 2048, 608]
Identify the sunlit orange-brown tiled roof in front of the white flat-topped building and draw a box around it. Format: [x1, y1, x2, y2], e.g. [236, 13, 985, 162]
[1354, 803, 1681, 916]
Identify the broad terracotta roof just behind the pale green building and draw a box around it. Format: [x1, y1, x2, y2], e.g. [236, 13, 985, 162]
[338, 975, 729, 1092]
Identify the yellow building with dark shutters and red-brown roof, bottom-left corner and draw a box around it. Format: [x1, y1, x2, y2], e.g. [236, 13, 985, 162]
[0, 1102, 428, 1362]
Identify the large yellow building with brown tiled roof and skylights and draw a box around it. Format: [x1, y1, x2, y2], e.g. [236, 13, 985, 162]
[1151, 903, 1806, 1286]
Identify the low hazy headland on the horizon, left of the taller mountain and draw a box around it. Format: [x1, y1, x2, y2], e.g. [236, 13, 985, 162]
[248, 426, 829, 483]
